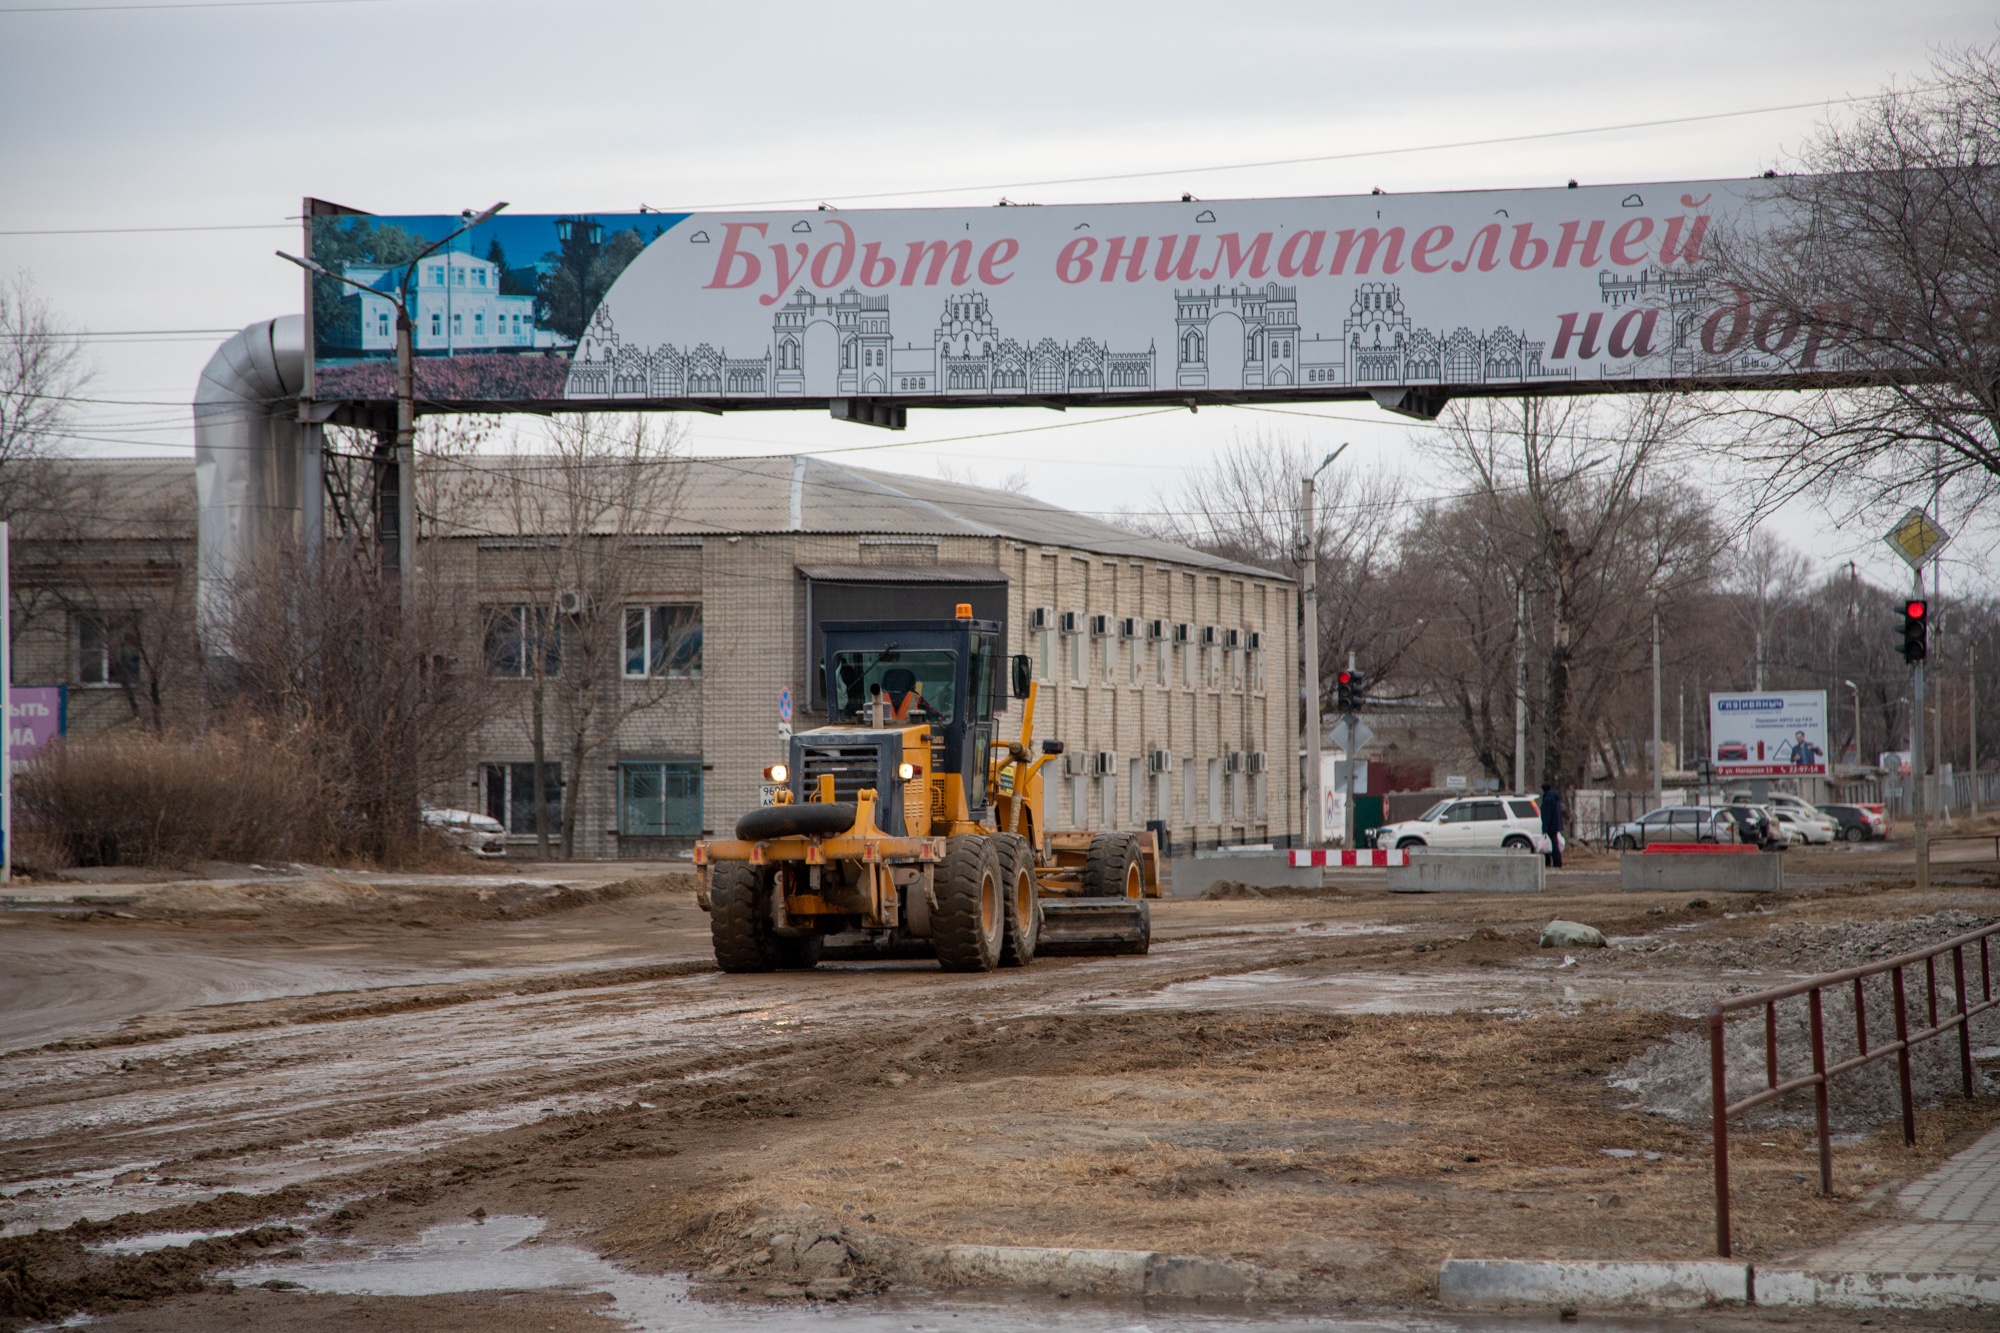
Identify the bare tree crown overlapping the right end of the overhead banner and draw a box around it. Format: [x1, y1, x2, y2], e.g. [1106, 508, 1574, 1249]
[1704, 42, 2000, 510]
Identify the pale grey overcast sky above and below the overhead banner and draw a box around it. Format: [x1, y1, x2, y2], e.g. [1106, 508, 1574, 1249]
[0, 0, 1996, 586]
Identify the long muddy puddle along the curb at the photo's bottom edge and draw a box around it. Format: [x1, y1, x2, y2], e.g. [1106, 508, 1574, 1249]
[214, 1217, 1680, 1333]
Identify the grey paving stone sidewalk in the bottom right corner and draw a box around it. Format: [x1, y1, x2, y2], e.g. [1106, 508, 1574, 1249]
[1800, 1129, 2000, 1273]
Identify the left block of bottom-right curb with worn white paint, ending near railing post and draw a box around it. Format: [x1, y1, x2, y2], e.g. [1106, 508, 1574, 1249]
[1438, 1259, 1750, 1309]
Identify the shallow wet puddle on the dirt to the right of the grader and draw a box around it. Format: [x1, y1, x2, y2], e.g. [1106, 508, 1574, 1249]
[1078, 969, 1728, 1013]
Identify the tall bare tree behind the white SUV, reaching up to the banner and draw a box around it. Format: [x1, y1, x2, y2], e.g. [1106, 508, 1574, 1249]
[1394, 396, 1724, 787]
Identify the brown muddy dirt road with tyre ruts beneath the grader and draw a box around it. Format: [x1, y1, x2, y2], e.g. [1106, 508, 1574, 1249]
[0, 844, 2000, 1329]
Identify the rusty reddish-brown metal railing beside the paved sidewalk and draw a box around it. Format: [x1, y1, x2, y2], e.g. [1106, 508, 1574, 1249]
[1708, 921, 2000, 1259]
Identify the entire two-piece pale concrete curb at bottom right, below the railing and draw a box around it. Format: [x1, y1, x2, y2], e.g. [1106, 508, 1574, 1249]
[1438, 1259, 2000, 1309]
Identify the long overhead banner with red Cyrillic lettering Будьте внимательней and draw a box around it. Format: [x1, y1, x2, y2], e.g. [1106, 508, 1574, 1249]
[306, 180, 1834, 408]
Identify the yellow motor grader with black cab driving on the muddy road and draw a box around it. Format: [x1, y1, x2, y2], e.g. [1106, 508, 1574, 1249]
[694, 602, 1160, 973]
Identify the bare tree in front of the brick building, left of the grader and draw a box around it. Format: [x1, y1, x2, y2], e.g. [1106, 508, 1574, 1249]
[456, 414, 700, 857]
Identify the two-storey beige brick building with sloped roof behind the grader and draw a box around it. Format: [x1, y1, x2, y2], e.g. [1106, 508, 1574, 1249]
[16, 456, 1302, 857]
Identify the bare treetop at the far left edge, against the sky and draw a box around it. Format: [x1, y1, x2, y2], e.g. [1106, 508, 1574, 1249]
[0, 272, 90, 518]
